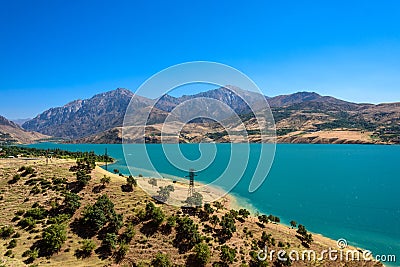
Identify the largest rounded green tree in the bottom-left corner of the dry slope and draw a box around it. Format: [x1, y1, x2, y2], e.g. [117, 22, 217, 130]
[40, 224, 67, 255]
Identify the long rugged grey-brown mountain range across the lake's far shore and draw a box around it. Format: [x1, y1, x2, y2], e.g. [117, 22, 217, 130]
[1, 86, 400, 143]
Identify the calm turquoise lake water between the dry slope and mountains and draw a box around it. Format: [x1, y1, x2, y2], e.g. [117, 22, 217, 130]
[31, 143, 400, 266]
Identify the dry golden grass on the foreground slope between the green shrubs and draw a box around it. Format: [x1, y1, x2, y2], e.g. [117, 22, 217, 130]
[0, 159, 381, 266]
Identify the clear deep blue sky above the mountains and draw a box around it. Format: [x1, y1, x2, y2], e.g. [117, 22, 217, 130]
[0, 0, 400, 119]
